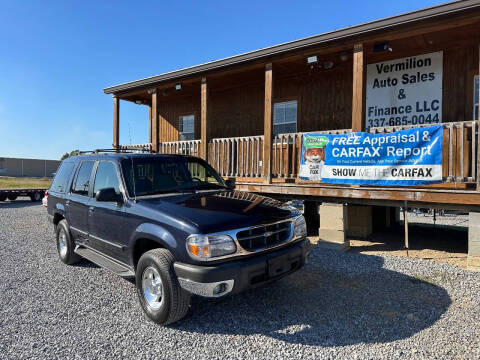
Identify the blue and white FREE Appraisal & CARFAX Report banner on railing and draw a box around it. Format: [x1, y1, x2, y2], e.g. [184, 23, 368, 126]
[300, 125, 443, 186]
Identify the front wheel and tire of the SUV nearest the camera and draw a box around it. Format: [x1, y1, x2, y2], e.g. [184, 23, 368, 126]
[135, 249, 190, 325]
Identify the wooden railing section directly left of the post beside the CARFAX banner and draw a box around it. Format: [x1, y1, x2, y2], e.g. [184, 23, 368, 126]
[208, 135, 263, 178]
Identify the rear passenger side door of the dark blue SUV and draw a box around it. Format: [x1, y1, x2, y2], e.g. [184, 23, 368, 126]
[65, 160, 95, 243]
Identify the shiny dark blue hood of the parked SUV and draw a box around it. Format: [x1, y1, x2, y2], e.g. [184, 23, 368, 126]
[141, 191, 292, 234]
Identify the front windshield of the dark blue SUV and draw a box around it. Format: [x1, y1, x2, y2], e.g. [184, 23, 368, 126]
[122, 156, 226, 196]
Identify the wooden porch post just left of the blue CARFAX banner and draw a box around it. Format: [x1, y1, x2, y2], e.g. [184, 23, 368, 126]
[263, 63, 273, 184]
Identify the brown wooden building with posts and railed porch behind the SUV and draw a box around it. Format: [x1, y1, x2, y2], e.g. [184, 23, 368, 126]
[104, 0, 480, 267]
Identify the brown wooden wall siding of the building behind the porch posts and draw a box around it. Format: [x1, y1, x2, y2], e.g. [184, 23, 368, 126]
[159, 44, 478, 142]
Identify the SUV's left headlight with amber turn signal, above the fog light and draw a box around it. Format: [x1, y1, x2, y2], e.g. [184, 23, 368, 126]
[187, 235, 237, 260]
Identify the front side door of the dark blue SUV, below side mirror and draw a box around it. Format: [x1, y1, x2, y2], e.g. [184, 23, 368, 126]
[88, 161, 128, 261]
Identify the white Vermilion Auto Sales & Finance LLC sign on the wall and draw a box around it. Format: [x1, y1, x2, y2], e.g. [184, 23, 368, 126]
[366, 51, 443, 128]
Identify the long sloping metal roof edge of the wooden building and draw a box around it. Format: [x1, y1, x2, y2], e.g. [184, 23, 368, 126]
[103, 0, 480, 94]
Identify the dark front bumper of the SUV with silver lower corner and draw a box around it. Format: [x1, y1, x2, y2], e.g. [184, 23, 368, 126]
[174, 239, 310, 297]
